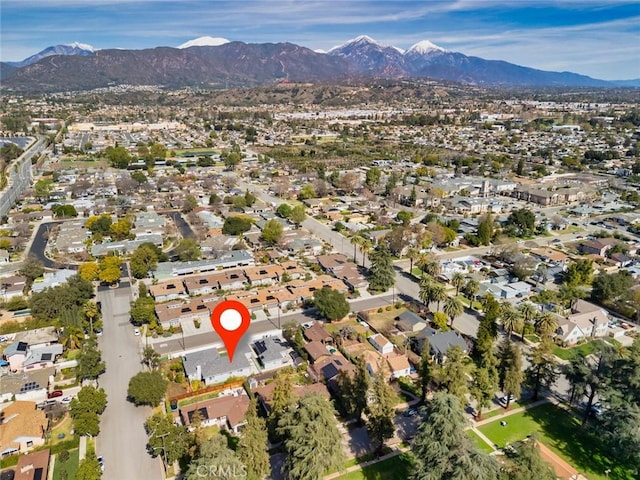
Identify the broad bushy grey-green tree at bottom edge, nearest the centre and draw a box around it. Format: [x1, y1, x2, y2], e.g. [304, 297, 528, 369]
[278, 394, 344, 480]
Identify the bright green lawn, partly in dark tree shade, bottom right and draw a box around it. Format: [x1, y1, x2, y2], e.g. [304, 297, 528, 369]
[478, 404, 634, 480]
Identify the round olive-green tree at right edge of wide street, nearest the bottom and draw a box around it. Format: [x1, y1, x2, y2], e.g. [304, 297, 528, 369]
[144, 412, 191, 468]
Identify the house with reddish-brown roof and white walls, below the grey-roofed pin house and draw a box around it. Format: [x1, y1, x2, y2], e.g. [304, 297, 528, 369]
[180, 392, 249, 433]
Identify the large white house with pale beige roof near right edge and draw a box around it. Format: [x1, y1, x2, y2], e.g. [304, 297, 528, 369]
[556, 299, 609, 344]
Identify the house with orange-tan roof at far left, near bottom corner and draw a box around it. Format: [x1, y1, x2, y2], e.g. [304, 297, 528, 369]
[0, 400, 49, 457]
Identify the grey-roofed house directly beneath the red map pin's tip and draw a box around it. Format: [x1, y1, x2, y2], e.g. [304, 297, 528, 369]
[182, 348, 256, 385]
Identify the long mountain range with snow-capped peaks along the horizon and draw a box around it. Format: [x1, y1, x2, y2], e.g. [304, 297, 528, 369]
[0, 35, 640, 92]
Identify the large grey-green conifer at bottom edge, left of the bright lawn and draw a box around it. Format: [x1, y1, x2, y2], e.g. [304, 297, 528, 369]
[411, 393, 499, 480]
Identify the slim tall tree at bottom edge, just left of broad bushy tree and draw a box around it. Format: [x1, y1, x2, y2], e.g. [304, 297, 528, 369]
[237, 398, 271, 480]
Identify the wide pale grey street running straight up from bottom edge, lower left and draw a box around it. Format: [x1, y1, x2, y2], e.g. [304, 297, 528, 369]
[97, 282, 163, 480]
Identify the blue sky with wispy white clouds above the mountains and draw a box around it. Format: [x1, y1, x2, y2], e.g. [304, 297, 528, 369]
[0, 0, 640, 80]
